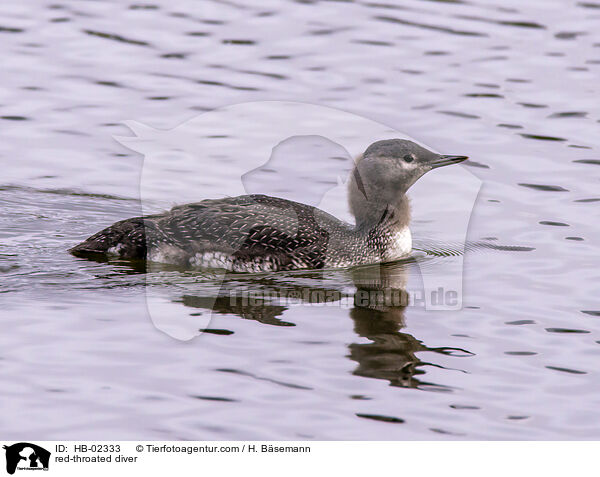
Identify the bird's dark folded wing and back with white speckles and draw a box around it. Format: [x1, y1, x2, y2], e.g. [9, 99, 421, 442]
[146, 195, 339, 268]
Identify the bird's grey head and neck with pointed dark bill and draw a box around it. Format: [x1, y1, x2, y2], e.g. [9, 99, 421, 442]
[349, 139, 467, 228]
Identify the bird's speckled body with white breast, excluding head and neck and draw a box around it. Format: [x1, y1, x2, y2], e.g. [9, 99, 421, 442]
[71, 195, 411, 272]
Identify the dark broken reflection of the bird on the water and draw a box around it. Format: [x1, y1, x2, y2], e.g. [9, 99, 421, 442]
[181, 262, 472, 391]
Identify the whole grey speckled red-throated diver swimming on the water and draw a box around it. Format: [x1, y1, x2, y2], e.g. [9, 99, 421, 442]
[70, 139, 467, 272]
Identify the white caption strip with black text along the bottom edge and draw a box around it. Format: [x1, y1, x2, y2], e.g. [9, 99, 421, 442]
[0, 441, 600, 477]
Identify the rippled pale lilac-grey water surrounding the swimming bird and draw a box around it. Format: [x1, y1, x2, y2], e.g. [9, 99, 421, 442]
[0, 0, 600, 440]
